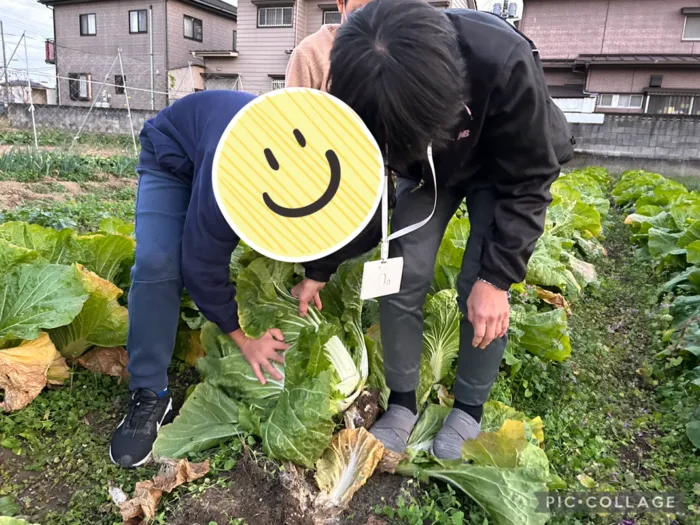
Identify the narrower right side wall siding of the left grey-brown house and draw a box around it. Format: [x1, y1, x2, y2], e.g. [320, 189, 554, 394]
[168, 0, 242, 69]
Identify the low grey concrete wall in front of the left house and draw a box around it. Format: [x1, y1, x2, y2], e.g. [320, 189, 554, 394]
[8, 104, 157, 135]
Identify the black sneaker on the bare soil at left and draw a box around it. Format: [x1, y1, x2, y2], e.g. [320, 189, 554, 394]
[109, 388, 173, 468]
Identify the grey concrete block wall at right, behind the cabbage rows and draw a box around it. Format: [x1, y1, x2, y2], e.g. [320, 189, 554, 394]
[571, 114, 700, 163]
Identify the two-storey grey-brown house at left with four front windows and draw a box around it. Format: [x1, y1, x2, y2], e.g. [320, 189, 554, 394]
[38, 0, 237, 109]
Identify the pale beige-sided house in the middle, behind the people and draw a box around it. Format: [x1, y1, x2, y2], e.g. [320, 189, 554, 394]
[204, 0, 476, 94]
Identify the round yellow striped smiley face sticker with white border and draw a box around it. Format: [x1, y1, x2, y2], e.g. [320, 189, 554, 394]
[213, 88, 384, 262]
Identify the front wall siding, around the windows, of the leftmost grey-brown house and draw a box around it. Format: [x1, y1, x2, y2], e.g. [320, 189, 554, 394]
[54, 0, 167, 109]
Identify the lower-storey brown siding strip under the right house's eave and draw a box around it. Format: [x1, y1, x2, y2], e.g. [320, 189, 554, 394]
[588, 68, 700, 93]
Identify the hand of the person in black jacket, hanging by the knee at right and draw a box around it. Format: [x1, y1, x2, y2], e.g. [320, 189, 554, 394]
[467, 281, 510, 350]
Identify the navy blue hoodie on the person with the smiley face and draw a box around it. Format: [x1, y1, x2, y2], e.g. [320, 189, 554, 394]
[137, 91, 381, 333]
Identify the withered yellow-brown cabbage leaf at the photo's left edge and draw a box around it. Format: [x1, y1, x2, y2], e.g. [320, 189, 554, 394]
[0, 332, 65, 412]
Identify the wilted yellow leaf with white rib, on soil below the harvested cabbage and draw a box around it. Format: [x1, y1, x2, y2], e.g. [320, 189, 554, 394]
[316, 427, 384, 508]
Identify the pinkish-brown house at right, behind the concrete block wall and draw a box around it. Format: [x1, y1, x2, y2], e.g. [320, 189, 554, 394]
[520, 0, 700, 116]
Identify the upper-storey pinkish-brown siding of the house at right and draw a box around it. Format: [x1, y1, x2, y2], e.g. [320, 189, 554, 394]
[520, 0, 700, 58]
